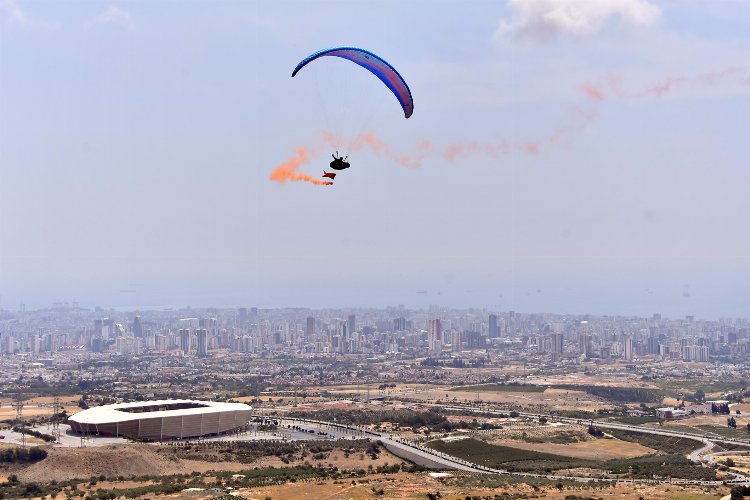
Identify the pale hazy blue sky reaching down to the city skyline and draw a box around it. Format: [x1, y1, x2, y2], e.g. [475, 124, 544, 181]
[0, 0, 750, 318]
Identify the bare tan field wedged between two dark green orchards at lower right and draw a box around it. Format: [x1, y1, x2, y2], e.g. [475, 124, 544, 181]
[490, 439, 656, 460]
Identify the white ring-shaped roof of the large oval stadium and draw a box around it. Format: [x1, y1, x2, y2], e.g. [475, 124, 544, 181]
[69, 399, 252, 425]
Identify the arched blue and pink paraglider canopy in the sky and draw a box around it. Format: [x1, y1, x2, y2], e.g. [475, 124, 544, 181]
[292, 47, 414, 118]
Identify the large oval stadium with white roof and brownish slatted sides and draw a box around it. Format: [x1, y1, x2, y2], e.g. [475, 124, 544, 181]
[68, 399, 252, 441]
